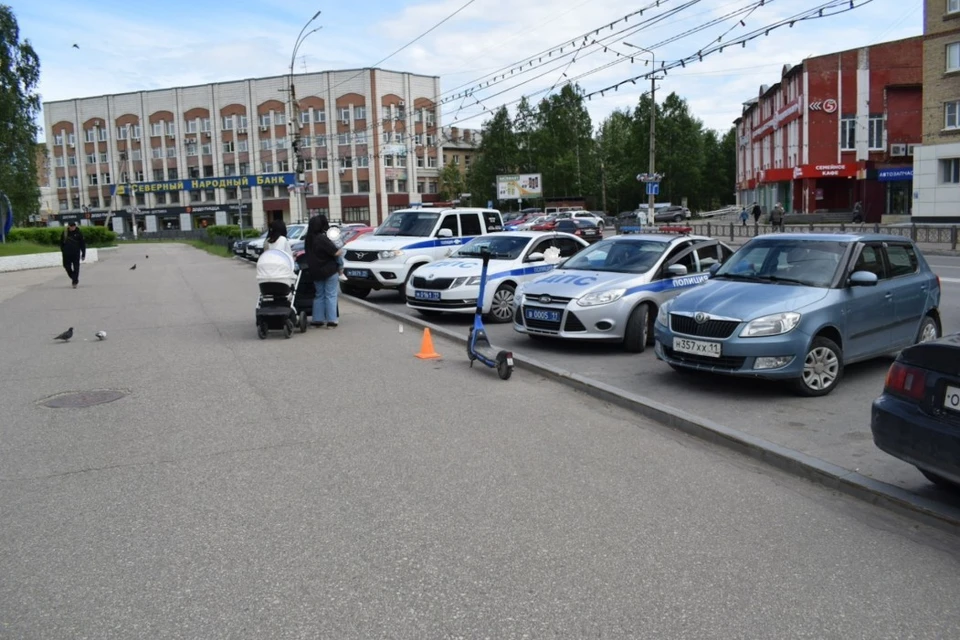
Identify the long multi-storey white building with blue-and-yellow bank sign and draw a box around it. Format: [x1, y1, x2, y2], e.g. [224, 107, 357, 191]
[44, 69, 443, 232]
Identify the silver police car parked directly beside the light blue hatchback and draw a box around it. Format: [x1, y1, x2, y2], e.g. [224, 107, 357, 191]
[513, 234, 733, 353]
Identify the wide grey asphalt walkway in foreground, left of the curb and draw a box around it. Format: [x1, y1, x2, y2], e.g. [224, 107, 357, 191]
[0, 244, 960, 639]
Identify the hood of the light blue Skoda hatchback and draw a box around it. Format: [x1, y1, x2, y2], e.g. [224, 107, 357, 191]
[670, 278, 830, 320]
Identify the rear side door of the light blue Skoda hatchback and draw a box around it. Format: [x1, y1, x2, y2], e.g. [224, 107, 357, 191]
[883, 242, 932, 347]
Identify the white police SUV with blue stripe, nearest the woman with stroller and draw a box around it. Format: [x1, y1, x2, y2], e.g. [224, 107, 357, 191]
[340, 207, 503, 298]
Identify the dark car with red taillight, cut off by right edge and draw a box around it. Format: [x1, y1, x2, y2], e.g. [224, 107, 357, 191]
[870, 336, 960, 491]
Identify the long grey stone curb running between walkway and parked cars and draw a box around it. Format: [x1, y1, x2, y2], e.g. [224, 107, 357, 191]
[340, 295, 960, 535]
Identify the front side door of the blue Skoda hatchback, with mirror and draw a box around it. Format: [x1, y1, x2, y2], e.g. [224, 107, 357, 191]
[842, 242, 895, 360]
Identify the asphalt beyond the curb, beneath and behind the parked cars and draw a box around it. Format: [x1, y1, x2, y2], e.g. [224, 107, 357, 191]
[356, 248, 960, 506]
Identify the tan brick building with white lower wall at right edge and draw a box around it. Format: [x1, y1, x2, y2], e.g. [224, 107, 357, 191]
[913, 0, 960, 222]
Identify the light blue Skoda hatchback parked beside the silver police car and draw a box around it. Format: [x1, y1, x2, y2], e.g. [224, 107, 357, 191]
[656, 233, 942, 396]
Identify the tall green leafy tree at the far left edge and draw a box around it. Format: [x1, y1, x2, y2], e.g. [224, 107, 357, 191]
[0, 4, 40, 224]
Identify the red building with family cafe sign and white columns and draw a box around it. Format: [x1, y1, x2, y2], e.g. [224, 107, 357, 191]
[735, 37, 923, 221]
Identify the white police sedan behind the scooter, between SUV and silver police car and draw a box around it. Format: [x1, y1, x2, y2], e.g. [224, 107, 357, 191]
[406, 231, 588, 322]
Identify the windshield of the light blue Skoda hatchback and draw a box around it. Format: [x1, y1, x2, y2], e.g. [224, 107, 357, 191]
[714, 238, 847, 287]
